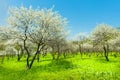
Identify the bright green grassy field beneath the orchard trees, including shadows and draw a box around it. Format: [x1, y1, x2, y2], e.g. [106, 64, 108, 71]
[0, 55, 120, 80]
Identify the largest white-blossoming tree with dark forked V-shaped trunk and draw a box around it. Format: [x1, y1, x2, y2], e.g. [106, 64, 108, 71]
[8, 7, 66, 69]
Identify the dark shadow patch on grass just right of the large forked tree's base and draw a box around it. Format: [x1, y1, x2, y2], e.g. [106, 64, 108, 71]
[31, 60, 75, 72]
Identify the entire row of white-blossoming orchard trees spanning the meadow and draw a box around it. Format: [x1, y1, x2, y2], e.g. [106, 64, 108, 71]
[0, 6, 120, 69]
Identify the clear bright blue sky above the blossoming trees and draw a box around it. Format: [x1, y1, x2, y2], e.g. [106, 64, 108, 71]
[0, 0, 120, 37]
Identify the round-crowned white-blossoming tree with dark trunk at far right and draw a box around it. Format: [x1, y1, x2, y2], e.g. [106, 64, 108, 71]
[91, 24, 117, 61]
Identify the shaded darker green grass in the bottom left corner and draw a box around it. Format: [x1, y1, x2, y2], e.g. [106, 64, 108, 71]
[0, 67, 33, 80]
